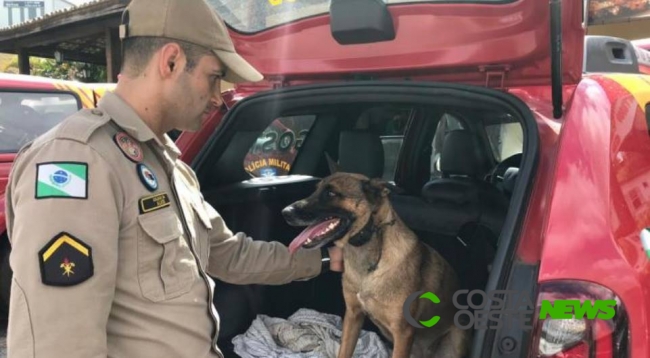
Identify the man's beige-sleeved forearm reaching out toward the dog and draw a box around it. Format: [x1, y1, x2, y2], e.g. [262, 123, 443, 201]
[205, 203, 321, 285]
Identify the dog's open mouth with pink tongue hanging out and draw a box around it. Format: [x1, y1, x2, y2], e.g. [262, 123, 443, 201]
[289, 216, 349, 254]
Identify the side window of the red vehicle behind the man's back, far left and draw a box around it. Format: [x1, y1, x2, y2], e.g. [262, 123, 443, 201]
[0, 92, 81, 153]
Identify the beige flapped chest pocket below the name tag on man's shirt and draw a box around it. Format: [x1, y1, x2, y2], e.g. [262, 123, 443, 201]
[138, 208, 197, 302]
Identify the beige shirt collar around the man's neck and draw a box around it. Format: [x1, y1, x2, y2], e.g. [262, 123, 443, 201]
[97, 92, 181, 159]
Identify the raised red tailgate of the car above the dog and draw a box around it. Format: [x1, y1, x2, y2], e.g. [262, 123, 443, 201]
[209, 0, 585, 88]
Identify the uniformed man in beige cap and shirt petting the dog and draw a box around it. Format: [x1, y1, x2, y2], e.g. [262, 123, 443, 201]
[6, 0, 342, 358]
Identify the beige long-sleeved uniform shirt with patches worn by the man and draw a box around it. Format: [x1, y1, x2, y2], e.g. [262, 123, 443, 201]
[6, 94, 321, 358]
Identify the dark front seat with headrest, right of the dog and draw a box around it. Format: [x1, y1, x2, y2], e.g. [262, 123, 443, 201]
[391, 130, 508, 303]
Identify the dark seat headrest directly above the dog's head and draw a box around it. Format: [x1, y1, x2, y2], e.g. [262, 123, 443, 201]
[339, 131, 384, 178]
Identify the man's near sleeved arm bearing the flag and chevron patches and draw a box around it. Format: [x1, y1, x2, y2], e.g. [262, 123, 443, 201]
[6, 139, 123, 358]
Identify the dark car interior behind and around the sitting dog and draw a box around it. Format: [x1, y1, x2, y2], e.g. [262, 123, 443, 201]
[197, 90, 523, 356]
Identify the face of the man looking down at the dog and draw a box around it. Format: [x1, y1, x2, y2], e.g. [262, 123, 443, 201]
[168, 55, 223, 131]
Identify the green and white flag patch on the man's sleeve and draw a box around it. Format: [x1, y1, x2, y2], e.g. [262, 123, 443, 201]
[36, 162, 88, 199]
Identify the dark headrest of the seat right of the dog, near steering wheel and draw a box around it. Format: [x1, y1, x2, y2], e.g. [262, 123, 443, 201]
[440, 130, 486, 177]
